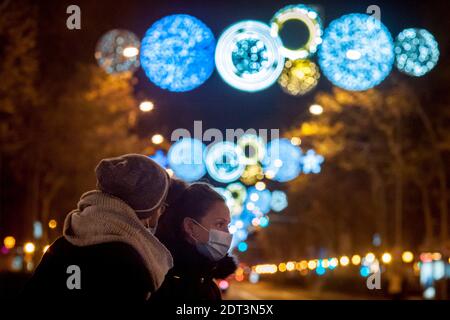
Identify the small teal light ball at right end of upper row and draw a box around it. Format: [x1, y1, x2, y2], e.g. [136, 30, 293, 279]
[395, 28, 439, 77]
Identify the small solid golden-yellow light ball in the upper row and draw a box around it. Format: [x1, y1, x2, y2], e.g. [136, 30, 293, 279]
[278, 60, 320, 96]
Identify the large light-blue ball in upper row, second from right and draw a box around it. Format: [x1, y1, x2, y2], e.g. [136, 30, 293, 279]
[319, 13, 394, 91]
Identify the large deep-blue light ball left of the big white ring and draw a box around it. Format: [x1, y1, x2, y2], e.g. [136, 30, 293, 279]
[141, 14, 216, 92]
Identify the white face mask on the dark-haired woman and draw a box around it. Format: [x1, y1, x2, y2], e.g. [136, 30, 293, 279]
[192, 219, 233, 261]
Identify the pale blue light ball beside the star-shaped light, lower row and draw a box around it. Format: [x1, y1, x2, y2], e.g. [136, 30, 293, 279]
[263, 138, 302, 182]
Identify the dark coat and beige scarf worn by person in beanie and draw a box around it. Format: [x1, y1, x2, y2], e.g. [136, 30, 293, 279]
[18, 191, 173, 304]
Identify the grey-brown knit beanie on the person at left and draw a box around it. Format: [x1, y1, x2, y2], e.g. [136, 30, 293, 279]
[95, 154, 170, 219]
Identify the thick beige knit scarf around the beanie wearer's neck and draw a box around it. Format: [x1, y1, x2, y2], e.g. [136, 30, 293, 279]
[63, 190, 173, 291]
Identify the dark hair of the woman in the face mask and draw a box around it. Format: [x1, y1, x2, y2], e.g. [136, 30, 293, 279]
[156, 179, 225, 247]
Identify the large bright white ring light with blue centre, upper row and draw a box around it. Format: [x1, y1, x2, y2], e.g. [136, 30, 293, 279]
[215, 20, 284, 92]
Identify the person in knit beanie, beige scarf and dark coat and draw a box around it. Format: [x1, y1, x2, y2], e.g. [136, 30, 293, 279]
[22, 154, 173, 304]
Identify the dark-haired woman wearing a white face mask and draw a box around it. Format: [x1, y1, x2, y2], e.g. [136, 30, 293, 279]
[150, 179, 237, 302]
